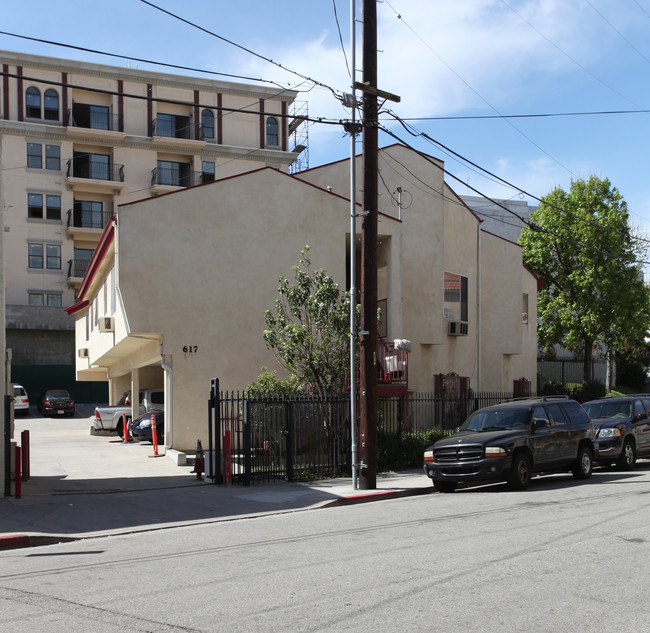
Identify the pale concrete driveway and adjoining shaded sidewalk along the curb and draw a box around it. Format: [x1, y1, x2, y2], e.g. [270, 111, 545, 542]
[0, 419, 433, 549]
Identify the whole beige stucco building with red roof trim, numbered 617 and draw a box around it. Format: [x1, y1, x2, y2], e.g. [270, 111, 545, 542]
[68, 146, 537, 451]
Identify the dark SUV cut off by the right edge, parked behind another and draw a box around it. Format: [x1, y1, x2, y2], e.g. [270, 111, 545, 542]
[584, 394, 650, 470]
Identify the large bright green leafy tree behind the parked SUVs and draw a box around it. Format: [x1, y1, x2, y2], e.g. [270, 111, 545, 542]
[520, 176, 650, 380]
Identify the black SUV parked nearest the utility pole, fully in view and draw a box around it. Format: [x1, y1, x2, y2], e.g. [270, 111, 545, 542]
[424, 396, 595, 492]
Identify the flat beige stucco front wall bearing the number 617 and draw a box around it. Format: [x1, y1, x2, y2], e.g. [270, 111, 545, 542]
[117, 169, 347, 449]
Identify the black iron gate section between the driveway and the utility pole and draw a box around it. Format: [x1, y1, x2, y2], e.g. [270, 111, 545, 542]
[207, 379, 351, 485]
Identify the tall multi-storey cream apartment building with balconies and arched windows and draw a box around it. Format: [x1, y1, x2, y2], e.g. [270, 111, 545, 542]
[0, 51, 299, 395]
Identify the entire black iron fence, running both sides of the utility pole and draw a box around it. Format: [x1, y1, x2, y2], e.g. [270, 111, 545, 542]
[206, 380, 528, 485]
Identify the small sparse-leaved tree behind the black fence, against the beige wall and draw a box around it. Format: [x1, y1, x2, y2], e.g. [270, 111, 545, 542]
[264, 246, 350, 393]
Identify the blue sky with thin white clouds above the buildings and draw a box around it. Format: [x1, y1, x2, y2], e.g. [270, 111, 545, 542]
[0, 0, 650, 237]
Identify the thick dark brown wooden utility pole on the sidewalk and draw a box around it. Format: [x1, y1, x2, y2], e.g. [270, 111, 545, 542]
[359, 0, 378, 490]
